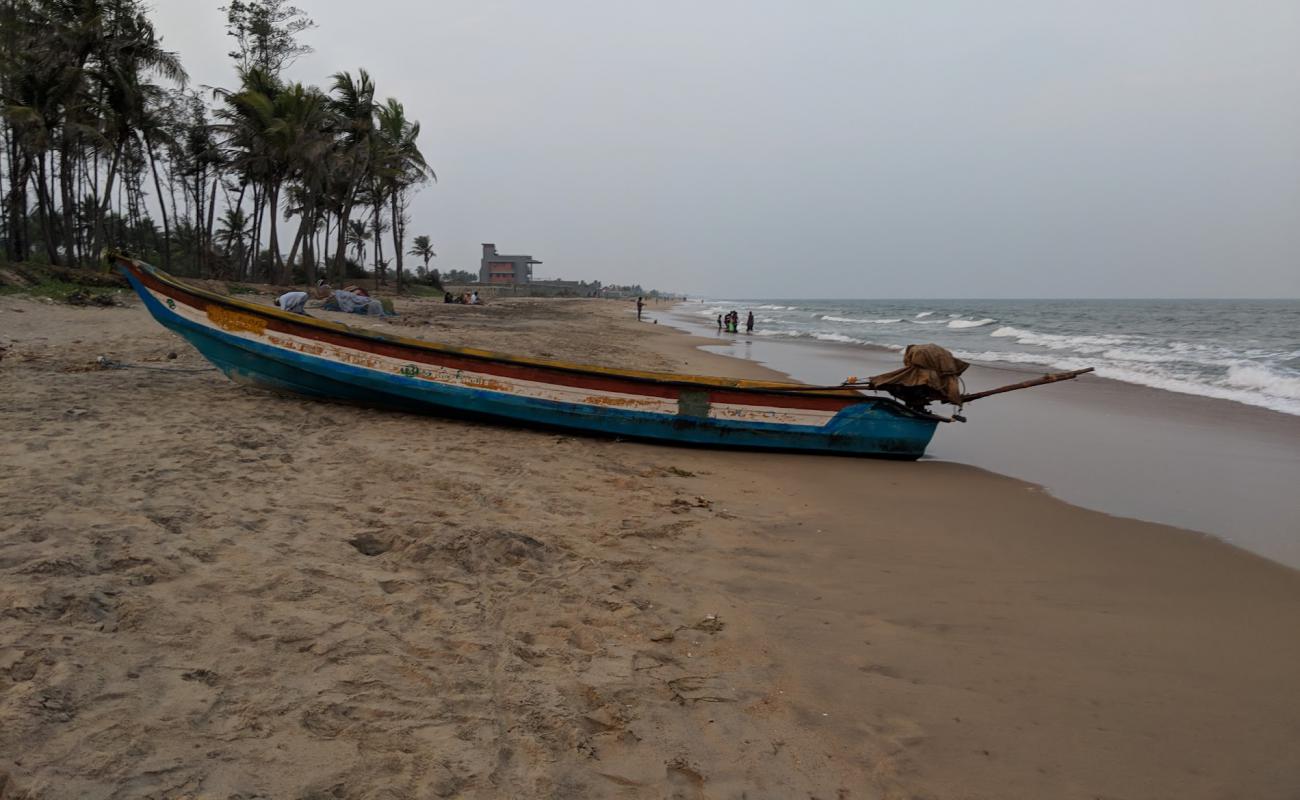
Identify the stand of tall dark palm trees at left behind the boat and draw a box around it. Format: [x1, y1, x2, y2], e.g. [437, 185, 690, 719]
[0, 0, 436, 286]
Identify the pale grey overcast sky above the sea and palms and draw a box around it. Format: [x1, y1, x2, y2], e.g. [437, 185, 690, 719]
[147, 0, 1300, 298]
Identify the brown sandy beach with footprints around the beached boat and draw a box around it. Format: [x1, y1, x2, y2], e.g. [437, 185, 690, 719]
[0, 297, 1300, 800]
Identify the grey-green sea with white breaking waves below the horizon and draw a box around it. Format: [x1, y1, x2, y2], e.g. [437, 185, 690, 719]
[680, 299, 1300, 415]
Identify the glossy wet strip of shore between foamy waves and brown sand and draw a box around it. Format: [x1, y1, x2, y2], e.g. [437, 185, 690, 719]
[657, 300, 1300, 568]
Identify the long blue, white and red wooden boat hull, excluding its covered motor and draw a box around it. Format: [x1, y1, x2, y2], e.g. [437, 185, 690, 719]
[111, 255, 1086, 459]
